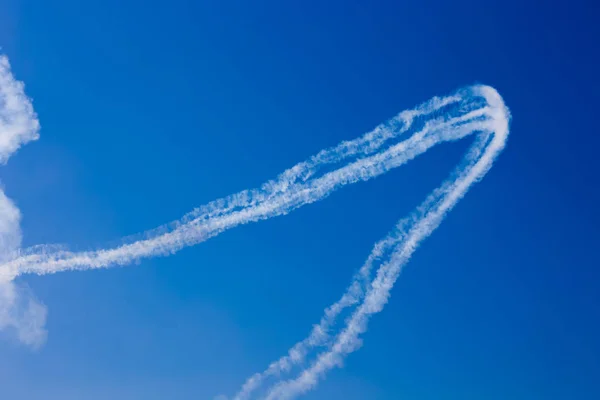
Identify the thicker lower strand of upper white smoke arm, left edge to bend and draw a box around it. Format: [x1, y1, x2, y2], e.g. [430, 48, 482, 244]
[0, 102, 486, 280]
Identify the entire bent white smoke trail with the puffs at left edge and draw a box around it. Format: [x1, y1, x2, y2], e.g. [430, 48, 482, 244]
[0, 57, 509, 400]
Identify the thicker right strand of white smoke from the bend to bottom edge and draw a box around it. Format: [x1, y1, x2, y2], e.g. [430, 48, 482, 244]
[251, 86, 509, 400]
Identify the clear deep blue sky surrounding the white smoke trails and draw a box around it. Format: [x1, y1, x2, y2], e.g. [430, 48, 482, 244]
[0, 0, 600, 400]
